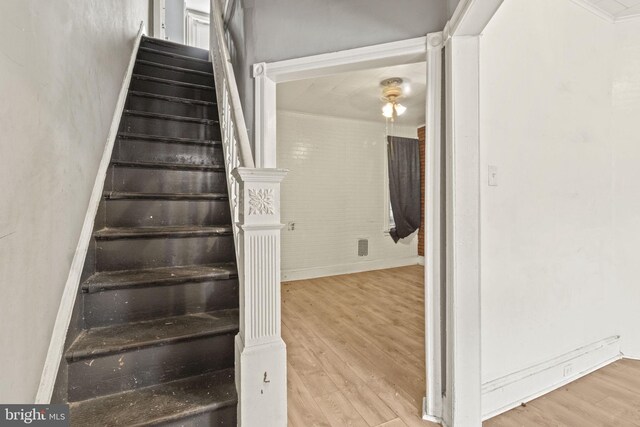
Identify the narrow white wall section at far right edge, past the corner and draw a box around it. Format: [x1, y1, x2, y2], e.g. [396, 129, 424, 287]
[612, 19, 640, 359]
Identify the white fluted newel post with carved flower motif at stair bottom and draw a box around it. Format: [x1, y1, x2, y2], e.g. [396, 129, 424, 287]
[233, 168, 287, 427]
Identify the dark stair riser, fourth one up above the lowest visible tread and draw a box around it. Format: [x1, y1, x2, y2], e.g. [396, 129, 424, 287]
[105, 199, 231, 227]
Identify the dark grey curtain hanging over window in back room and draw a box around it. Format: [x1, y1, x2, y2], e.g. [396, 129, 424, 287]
[387, 136, 420, 243]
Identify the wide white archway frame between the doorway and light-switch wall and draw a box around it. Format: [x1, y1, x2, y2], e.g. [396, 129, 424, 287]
[441, 0, 503, 426]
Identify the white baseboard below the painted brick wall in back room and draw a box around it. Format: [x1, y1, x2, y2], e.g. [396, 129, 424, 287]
[281, 256, 418, 281]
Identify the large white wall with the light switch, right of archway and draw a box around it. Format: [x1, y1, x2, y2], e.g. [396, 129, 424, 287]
[480, 0, 616, 386]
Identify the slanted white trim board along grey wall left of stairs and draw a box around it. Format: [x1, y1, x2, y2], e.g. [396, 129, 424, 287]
[35, 22, 145, 404]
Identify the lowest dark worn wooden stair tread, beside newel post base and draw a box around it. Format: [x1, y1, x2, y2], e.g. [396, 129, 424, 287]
[70, 369, 238, 427]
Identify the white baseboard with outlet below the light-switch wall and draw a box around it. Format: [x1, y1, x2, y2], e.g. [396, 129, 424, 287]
[482, 336, 622, 420]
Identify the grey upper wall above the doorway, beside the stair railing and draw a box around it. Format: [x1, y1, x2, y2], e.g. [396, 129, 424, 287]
[229, 0, 447, 153]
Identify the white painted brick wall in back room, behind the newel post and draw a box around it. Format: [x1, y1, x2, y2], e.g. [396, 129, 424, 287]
[277, 111, 418, 280]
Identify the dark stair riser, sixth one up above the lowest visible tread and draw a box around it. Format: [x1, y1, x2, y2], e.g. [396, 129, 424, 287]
[112, 139, 224, 165]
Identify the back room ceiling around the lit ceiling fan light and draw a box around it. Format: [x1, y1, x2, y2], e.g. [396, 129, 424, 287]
[277, 62, 427, 126]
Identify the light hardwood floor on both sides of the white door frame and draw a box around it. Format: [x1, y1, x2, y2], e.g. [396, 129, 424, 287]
[282, 266, 640, 427]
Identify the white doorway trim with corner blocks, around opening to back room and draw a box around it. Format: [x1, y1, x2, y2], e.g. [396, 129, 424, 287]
[252, 36, 453, 422]
